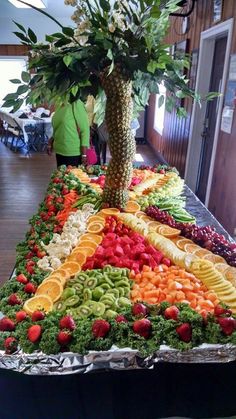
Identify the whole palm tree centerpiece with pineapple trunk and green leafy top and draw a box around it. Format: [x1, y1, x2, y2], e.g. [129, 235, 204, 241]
[5, 0, 199, 208]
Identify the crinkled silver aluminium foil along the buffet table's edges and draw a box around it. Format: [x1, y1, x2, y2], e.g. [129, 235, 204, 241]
[0, 185, 236, 375]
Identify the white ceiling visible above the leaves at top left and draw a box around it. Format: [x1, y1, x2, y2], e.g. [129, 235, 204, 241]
[0, 0, 74, 18]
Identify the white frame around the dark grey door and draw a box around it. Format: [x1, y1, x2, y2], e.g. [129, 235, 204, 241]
[184, 18, 234, 206]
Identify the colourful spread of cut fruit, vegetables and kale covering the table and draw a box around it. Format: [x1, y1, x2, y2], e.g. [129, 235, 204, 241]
[0, 166, 236, 364]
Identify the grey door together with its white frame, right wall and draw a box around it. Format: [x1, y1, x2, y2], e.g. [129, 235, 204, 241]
[185, 18, 234, 206]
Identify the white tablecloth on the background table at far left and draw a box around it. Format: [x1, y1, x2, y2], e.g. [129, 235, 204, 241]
[0, 108, 53, 143]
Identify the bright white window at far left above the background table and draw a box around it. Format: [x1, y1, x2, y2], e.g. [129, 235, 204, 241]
[0, 57, 27, 106]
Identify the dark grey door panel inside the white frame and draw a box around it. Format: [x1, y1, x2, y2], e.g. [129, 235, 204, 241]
[196, 37, 227, 202]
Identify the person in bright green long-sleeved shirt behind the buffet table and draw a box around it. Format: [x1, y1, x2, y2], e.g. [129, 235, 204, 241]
[47, 100, 90, 167]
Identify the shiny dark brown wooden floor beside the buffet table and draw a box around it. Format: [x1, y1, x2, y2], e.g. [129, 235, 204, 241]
[0, 142, 157, 284]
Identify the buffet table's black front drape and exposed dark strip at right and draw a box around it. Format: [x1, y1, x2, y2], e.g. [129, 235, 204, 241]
[0, 176, 236, 419]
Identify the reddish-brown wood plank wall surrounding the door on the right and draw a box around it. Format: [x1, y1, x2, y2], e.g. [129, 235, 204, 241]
[147, 0, 236, 234]
